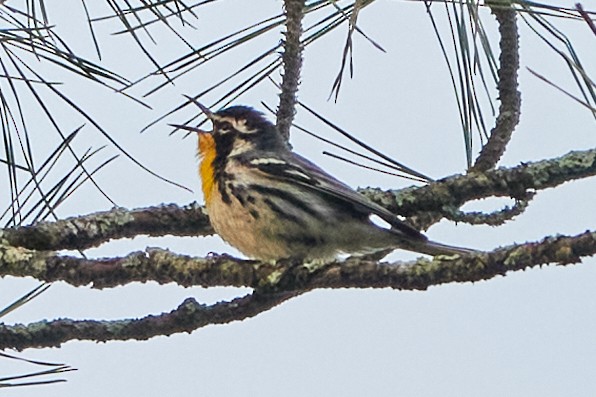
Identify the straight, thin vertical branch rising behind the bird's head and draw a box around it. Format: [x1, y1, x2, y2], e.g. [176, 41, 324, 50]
[276, 0, 304, 141]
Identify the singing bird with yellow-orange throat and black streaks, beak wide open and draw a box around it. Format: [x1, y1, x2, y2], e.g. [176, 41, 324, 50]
[173, 103, 474, 261]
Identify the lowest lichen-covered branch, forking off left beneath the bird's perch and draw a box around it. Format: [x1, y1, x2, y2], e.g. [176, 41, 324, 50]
[0, 293, 296, 350]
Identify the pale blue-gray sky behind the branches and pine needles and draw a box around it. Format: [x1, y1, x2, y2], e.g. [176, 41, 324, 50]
[0, 1, 596, 397]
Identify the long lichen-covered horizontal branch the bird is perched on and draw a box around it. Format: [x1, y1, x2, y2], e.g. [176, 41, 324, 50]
[0, 232, 596, 292]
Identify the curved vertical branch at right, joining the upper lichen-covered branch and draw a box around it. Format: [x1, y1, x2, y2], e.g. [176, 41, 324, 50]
[472, 0, 521, 171]
